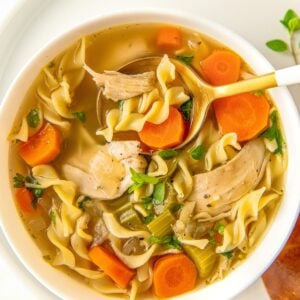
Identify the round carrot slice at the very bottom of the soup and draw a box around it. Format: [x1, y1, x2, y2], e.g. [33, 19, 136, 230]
[153, 253, 197, 298]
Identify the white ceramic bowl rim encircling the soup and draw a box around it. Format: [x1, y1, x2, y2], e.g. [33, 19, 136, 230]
[0, 10, 300, 300]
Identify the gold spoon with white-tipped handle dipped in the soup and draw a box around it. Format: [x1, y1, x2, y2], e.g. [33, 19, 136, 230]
[98, 57, 300, 149]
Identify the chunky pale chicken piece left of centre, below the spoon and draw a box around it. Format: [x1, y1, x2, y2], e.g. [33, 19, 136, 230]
[62, 141, 146, 200]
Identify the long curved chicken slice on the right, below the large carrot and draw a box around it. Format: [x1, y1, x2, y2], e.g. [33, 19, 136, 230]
[188, 139, 267, 213]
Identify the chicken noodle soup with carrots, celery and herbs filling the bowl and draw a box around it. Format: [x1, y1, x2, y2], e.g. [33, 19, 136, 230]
[9, 24, 287, 299]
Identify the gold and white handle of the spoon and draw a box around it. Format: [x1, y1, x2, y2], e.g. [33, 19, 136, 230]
[213, 65, 300, 99]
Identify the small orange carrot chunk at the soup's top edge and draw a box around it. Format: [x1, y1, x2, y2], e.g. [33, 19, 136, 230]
[156, 27, 182, 51]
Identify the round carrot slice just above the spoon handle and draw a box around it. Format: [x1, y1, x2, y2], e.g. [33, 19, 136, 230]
[201, 50, 241, 85]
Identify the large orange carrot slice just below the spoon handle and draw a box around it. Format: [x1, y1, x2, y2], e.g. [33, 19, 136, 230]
[213, 93, 270, 142]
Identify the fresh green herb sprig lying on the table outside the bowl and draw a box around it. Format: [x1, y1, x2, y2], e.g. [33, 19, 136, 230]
[266, 9, 300, 64]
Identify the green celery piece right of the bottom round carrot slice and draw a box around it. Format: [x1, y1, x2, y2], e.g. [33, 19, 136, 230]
[182, 245, 219, 278]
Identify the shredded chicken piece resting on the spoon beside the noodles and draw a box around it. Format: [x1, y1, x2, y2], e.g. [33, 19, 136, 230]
[85, 66, 155, 101]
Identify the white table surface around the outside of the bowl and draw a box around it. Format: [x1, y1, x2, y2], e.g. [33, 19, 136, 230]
[0, 0, 300, 300]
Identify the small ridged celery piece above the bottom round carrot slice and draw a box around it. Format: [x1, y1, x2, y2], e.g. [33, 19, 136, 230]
[147, 209, 176, 237]
